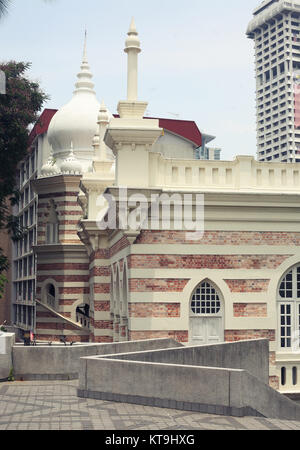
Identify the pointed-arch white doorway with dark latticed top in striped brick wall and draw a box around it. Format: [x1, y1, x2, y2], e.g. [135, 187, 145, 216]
[189, 280, 224, 345]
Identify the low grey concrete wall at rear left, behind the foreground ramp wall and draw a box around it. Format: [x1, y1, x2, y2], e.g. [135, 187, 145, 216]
[12, 339, 182, 380]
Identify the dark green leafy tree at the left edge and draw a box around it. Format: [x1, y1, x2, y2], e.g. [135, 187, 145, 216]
[0, 60, 48, 274]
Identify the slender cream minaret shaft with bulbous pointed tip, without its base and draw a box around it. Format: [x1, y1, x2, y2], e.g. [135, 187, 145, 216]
[124, 18, 141, 102]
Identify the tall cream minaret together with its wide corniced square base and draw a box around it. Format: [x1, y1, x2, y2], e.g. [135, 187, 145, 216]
[104, 19, 162, 187]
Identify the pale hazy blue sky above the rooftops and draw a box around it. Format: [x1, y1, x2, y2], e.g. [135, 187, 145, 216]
[0, 0, 261, 160]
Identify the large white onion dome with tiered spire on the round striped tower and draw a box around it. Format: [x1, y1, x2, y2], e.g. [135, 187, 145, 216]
[48, 34, 100, 159]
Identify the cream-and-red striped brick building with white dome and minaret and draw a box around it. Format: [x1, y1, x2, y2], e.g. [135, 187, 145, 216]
[13, 21, 300, 392]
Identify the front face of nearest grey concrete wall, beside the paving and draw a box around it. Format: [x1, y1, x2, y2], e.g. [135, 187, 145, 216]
[78, 358, 253, 416]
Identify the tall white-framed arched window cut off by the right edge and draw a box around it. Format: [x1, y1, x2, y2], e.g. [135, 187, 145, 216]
[277, 265, 300, 351]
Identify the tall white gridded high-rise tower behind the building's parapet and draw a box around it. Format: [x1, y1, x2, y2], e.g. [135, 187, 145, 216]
[247, 0, 300, 162]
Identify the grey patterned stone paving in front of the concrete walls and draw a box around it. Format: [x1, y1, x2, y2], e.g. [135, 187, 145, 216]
[0, 381, 300, 431]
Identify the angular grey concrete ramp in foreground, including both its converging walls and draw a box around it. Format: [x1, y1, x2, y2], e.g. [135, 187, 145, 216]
[78, 339, 300, 420]
